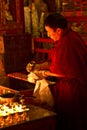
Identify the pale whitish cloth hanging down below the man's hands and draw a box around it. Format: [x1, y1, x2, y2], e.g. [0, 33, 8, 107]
[33, 79, 54, 107]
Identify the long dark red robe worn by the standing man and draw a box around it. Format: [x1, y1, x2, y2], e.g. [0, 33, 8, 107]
[50, 28, 87, 130]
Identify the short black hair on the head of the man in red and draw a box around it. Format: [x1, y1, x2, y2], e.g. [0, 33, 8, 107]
[44, 13, 68, 30]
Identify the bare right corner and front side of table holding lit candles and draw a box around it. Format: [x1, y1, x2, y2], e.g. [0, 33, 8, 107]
[1, 104, 56, 130]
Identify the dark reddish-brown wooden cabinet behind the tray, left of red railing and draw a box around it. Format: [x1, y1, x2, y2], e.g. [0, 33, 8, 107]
[3, 34, 32, 74]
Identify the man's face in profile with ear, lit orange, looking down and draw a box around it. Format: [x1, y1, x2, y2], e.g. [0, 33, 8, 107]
[45, 26, 63, 41]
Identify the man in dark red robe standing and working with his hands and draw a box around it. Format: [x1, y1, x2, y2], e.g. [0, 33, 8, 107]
[26, 13, 87, 130]
